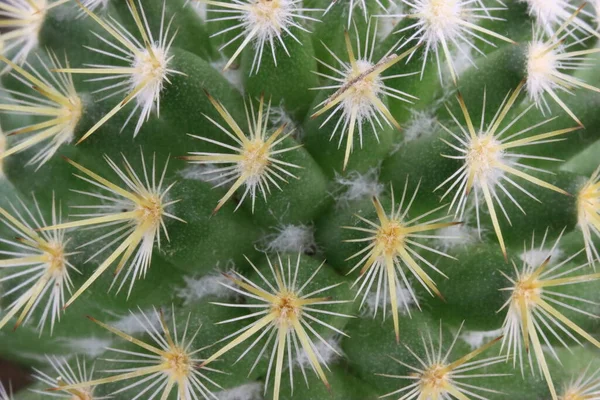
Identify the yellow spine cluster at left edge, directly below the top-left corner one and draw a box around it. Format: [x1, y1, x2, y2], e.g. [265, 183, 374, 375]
[0, 52, 83, 169]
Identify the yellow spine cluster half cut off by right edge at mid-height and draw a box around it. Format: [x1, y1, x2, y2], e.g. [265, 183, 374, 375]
[577, 167, 600, 268]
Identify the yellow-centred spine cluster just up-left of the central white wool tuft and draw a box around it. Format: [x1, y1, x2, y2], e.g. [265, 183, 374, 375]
[182, 95, 301, 213]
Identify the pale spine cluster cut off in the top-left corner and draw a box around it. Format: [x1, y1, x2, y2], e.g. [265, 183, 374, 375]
[0, 0, 67, 68]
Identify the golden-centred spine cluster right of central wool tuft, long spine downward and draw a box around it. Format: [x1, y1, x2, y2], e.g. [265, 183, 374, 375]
[343, 179, 457, 341]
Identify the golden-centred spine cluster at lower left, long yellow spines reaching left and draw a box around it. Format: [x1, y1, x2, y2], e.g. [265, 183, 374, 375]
[50, 309, 221, 400]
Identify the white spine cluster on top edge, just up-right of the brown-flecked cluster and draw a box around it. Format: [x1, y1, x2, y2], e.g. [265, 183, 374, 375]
[392, 0, 512, 83]
